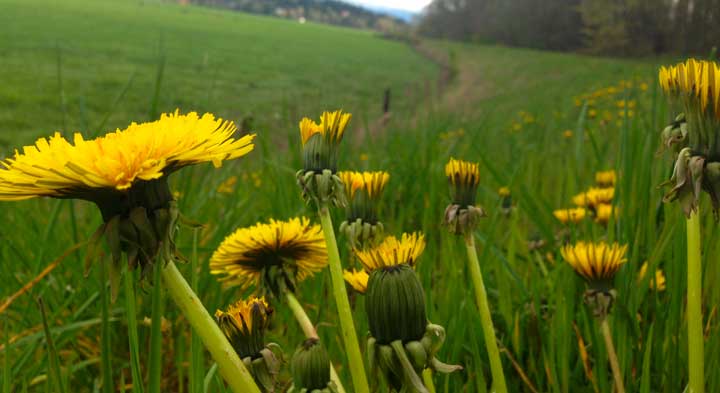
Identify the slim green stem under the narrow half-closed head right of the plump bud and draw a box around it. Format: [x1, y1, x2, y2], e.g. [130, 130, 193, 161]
[465, 231, 507, 393]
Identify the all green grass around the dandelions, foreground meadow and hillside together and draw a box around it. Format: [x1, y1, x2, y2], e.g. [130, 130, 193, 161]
[0, 0, 720, 393]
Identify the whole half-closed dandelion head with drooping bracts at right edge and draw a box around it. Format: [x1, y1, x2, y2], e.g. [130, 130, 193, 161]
[659, 59, 720, 219]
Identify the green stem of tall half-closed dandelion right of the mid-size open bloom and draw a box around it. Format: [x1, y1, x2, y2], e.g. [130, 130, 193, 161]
[318, 204, 370, 393]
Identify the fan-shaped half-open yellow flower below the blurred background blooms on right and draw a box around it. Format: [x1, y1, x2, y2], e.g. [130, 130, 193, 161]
[560, 241, 628, 282]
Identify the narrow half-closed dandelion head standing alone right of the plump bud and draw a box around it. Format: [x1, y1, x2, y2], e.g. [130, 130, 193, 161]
[443, 158, 485, 235]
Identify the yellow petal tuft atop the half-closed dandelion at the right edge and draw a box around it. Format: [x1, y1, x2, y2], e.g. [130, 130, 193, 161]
[659, 59, 720, 119]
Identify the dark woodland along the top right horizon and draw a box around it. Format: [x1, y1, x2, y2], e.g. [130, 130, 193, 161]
[419, 0, 720, 55]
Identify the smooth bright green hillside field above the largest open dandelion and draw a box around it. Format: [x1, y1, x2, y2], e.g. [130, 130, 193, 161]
[0, 0, 434, 144]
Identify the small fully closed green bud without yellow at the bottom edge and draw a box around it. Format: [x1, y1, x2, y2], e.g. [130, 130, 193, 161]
[292, 338, 335, 392]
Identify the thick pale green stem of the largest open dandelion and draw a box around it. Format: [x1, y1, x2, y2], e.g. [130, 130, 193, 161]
[162, 261, 260, 393]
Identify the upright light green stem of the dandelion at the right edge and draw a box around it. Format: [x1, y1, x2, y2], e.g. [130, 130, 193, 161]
[687, 212, 705, 393]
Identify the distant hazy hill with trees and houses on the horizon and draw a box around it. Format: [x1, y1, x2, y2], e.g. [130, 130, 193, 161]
[178, 0, 404, 31]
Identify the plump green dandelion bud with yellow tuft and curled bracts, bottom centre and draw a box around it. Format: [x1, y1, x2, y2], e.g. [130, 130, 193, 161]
[355, 234, 462, 393]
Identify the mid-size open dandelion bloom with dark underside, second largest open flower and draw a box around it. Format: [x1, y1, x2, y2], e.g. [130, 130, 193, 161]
[210, 217, 328, 293]
